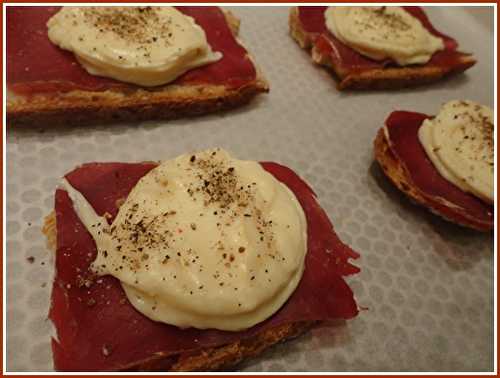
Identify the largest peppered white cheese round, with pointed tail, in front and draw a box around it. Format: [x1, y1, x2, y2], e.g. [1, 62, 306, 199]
[60, 149, 307, 331]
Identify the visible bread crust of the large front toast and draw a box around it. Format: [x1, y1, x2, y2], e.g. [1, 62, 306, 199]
[42, 211, 316, 371]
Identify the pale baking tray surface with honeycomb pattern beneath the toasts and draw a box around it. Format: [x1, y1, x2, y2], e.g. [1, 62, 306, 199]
[5, 7, 494, 371]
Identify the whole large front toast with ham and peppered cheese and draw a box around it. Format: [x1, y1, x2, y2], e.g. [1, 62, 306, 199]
[44, 149, 359, 371]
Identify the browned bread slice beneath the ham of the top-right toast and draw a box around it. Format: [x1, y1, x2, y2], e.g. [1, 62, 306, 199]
[289, 7, 476, 90]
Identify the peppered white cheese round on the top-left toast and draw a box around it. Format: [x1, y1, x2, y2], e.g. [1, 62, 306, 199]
[47, 7, 222, 87]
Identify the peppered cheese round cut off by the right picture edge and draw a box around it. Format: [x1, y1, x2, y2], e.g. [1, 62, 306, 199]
[419, 100, 494, 203]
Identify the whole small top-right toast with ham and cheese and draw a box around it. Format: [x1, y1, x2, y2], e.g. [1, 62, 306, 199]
[289, 6, 476, 89]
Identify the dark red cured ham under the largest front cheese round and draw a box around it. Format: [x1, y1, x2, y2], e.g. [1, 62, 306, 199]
[50, 162, 359, 371]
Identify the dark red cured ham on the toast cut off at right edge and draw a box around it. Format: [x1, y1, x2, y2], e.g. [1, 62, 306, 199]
[385, 111, 493, 229]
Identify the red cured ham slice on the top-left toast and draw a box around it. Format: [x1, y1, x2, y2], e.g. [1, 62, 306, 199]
[6, 6, 256, 94]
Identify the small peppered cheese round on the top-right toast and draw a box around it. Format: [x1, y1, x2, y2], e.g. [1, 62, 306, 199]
[325, 6, 444, 66]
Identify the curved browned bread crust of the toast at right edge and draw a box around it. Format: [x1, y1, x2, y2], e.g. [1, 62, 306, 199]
[374, 128, 493, 231]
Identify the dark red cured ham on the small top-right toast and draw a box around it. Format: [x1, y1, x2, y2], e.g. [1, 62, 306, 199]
[299, 6, 472, 72]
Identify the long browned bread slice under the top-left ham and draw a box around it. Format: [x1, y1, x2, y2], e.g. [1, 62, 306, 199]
[7, 10, 269, 126]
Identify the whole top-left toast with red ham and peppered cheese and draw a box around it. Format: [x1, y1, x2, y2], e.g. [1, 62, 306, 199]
[6, 6, 268, 125]
